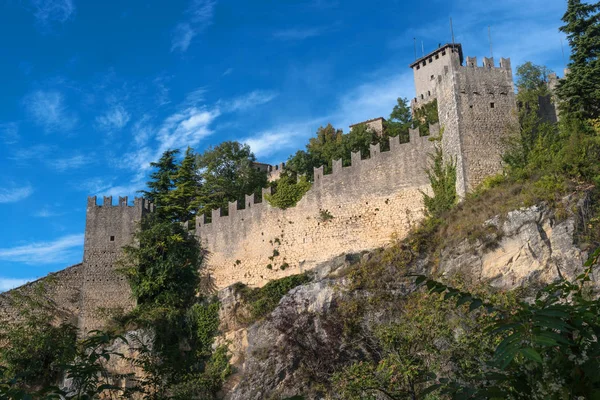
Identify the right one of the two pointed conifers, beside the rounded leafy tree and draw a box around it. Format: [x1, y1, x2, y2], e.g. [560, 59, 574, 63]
[165, 147, 200, 222]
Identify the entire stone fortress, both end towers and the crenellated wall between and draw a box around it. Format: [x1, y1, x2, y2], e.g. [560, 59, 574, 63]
[0, 44, 516, 332]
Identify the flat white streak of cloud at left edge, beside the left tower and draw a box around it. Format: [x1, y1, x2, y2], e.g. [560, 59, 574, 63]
[0, 234, 83, 265]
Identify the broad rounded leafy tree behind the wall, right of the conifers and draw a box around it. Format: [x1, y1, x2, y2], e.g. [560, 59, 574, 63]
[197, 142, 267, 215]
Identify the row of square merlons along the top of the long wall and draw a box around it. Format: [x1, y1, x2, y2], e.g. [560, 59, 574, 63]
[196, 124, 440, 228]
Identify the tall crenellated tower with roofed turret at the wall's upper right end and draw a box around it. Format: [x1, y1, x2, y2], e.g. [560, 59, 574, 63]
[410, 43, 518, 197]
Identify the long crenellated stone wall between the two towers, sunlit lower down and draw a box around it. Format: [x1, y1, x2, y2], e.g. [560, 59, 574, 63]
[196, 126, 439, 288]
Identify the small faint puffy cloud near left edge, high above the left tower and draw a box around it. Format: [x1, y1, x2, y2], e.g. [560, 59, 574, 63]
[24, 90, 78, 132]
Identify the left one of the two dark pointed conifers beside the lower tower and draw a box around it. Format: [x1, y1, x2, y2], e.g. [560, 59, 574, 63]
[140, 150, 179, 214]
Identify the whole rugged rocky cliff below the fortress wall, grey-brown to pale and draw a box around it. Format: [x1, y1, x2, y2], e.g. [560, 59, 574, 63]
[219, 195, 589, 400]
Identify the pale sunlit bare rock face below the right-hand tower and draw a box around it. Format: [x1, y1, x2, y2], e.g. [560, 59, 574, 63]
[440, 202, 587, 289]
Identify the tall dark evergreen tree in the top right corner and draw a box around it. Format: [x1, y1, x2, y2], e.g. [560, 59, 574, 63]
[557, 0, 600, 119]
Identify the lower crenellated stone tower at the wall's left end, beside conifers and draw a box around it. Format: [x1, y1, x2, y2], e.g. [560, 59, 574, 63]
[79, 196, 154, 335]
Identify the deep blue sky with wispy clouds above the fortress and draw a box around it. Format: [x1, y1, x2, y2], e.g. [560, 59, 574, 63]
[0, 0, 568, 291]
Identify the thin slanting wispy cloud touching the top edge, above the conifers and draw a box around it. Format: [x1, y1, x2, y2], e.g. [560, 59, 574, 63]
[171, 0, 217, 53]
